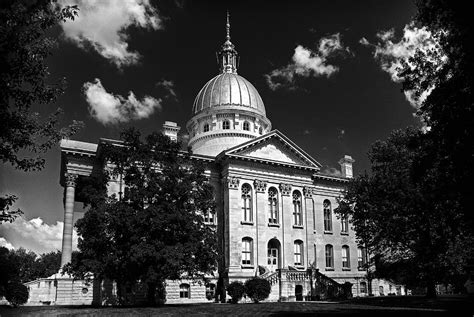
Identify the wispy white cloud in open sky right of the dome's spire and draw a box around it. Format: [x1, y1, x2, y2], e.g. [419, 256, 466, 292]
[265, 33, 350, 90]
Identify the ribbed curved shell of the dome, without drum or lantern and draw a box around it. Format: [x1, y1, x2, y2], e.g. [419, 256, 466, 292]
[193, 72, 265, 116]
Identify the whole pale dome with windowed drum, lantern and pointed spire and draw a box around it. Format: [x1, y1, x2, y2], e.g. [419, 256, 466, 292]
[186, 16, 272, 157]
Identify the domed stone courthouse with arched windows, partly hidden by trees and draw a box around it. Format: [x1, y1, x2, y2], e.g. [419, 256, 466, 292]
[27, 16, 401, 304]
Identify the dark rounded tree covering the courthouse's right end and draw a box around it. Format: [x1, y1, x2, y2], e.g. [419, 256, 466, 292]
[336, 128, 472, 296]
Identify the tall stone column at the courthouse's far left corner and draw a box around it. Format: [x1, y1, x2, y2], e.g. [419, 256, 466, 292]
[61, 173, 77, 267]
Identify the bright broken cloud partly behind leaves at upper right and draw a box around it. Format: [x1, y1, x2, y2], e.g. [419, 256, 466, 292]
[359, 23, 441, 108]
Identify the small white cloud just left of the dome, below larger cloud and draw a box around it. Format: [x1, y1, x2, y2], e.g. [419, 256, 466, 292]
[83, 78, 161, 125]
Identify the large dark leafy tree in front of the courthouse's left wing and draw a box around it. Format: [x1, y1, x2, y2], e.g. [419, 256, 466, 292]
[70, 129, 217, 304]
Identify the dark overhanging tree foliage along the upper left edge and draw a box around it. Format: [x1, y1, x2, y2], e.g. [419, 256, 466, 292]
[0, 0, 81, 222]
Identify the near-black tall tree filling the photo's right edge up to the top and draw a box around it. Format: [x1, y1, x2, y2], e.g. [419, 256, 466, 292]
[399, 0, 474, 264]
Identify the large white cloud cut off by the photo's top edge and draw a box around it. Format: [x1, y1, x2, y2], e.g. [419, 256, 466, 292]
[60, 0, 162, 68]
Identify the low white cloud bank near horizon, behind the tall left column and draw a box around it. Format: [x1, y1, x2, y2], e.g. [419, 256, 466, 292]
[0, 217, 77, 254]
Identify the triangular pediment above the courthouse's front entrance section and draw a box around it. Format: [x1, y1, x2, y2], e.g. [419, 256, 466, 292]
[223, 130, 321, 170]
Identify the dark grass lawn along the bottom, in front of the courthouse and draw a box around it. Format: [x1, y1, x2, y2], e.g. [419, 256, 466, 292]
[0, 296, 474, 317]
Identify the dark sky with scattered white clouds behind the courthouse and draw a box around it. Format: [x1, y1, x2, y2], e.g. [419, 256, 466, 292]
[0, 0, 430, 253]
